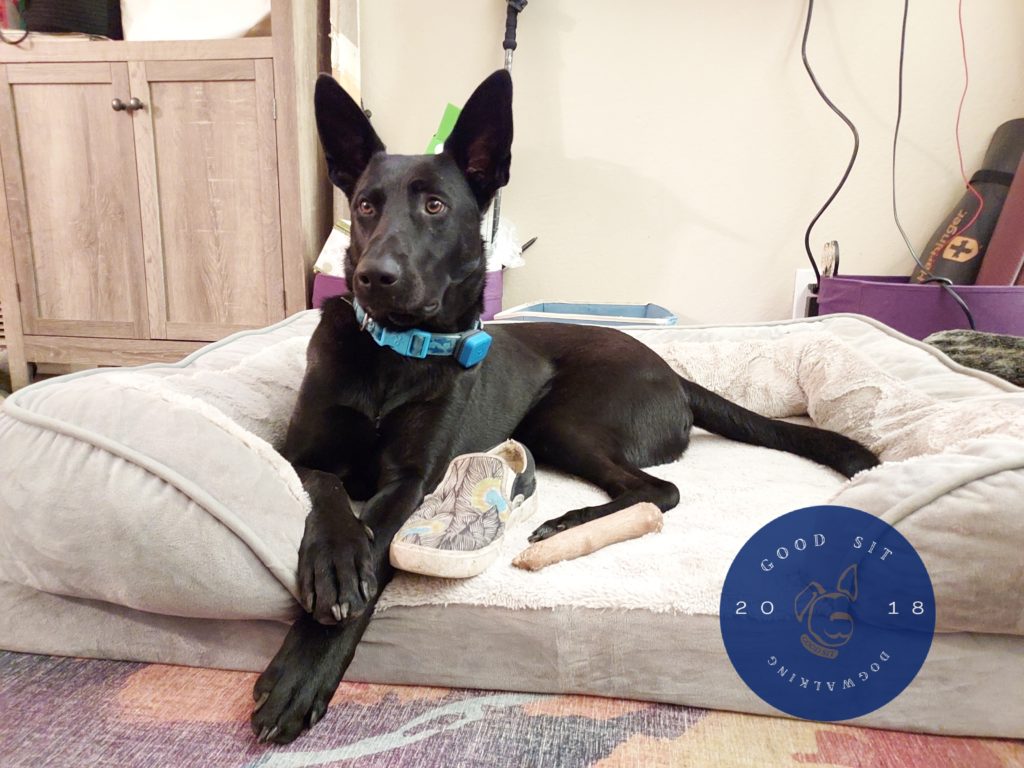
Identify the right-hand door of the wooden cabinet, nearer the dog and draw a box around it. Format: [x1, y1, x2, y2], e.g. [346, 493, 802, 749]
[129, 59, 285, 340]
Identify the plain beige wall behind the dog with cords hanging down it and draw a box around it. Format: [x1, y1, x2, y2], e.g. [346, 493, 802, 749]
[361, 0, 1024, 323]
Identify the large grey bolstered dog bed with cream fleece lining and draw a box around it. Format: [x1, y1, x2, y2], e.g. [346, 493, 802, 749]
[0, 311, 1024, 737]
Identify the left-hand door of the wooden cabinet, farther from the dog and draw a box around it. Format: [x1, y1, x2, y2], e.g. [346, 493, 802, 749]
[0, 62, 148, 338]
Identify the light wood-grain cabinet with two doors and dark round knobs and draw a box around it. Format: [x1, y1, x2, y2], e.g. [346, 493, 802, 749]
[0, 2, 331, 387]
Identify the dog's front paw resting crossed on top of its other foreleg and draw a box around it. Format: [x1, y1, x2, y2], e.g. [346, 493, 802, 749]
[299, 511, 377, 624]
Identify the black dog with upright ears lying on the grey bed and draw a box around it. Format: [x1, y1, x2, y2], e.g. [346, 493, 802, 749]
[252, 72, 878, 742]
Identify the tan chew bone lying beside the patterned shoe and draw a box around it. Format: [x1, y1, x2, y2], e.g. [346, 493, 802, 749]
[512, 502, 664, 570]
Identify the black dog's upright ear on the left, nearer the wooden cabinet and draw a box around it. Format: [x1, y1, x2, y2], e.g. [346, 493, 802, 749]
[313, 75, 384, 198]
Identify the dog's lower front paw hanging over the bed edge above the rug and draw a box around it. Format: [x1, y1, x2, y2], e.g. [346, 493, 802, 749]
[250, 617, 344, 744]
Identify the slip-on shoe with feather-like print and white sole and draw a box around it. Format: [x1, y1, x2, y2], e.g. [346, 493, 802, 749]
[390, 440, 537, 579]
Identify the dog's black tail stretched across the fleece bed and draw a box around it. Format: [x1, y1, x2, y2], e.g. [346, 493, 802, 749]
[680, 377, 879, 477]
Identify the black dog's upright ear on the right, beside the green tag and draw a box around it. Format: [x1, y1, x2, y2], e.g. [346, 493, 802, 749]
[444, 70, 512, 205]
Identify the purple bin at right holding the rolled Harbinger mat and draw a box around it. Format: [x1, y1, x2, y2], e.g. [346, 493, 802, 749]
[818, 275, 1024, 339]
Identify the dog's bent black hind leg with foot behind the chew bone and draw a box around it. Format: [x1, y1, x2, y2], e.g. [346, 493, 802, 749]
[516, 428, 679, 542]
